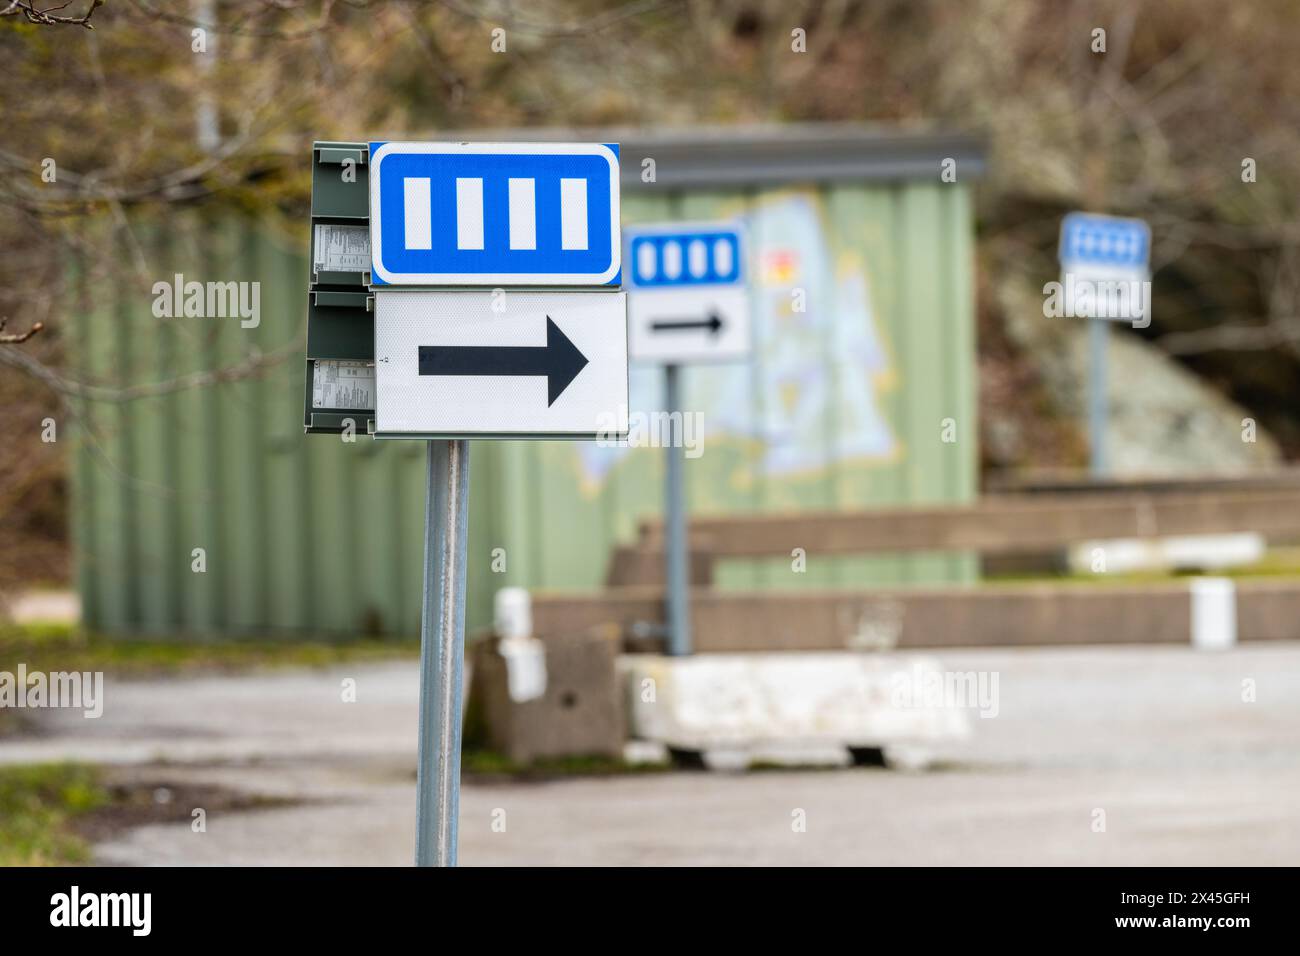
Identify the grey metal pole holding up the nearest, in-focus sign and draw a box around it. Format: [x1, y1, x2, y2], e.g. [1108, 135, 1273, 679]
[415, 440, 469, 866]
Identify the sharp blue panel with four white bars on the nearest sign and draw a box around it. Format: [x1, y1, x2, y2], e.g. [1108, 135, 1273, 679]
[371, 142, 621, 286]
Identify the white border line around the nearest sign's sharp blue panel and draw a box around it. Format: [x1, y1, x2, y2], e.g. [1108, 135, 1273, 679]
[369, 142, 623, 287]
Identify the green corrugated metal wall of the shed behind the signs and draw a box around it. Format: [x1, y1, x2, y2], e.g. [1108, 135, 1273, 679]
[74, 182, 976, 636]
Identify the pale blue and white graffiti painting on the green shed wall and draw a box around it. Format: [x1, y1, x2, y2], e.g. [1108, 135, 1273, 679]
[576, 193, 898, 486]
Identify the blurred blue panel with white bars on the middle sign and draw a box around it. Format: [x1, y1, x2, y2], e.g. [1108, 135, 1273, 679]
[628, 226, 744, 290]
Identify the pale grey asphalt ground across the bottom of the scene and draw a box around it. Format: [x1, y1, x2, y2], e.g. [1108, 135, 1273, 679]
[0, 643, 1300, 865]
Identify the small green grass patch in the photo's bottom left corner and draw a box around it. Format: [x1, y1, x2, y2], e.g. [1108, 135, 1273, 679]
[0, 763, 109, 866]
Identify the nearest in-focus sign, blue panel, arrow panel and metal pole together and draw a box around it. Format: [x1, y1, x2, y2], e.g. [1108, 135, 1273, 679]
[322, 140, 626, 866]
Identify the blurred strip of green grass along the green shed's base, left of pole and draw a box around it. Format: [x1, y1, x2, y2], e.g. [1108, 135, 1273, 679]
[0, 624, 420, 676]
